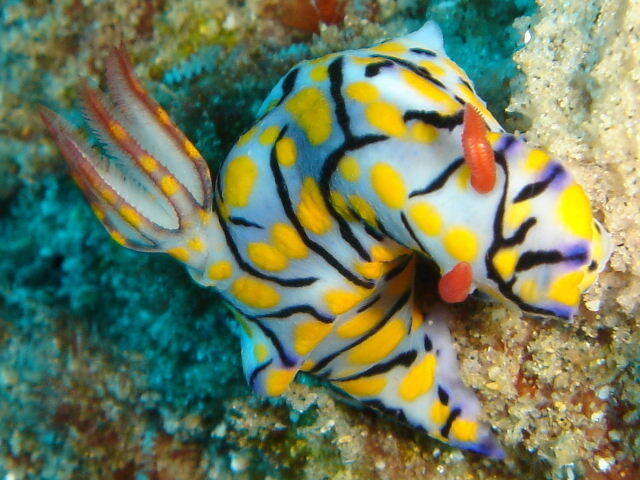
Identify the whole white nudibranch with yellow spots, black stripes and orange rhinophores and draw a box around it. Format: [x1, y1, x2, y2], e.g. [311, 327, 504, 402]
[41, 22, 608, 458]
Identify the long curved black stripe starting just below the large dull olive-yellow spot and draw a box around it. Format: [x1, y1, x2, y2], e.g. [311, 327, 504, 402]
[270, 125, 374, 288]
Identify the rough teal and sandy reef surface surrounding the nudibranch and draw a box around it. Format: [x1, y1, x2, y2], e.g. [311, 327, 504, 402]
[0, 0, 640, 480]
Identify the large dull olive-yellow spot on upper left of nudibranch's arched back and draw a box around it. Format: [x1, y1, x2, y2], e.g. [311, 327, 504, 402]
[286, 87, 333, 145]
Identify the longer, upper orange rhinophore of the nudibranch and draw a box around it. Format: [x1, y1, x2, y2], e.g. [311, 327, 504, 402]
[462, 103, 496, 193]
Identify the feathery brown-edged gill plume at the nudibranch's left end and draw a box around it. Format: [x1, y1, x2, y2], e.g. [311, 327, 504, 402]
[40, 50, 212, 266]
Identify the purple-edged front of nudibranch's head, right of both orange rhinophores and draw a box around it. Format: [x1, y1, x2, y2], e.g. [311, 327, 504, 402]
[479, 134, 610, 319]
